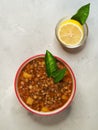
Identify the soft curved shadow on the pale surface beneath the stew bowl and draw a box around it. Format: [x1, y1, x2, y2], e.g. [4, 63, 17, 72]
[28, 106, 71, 125]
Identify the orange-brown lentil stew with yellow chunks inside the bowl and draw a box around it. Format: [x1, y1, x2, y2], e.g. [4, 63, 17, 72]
[18, 57, 73, 112]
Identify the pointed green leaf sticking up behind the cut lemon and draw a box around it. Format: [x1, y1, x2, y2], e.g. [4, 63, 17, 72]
[71, 3, 90, 25]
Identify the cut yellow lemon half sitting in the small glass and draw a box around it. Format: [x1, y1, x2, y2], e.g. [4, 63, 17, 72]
[57, 19, 84, 45]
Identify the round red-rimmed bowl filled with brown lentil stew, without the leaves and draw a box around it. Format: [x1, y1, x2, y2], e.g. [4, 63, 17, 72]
[14, 54, 76, 116]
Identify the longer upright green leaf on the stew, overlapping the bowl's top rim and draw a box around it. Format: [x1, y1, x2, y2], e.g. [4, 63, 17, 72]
[45, 50, 57, 77]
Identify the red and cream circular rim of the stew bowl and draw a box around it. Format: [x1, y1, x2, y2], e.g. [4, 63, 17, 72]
[14, 54, 76, 116]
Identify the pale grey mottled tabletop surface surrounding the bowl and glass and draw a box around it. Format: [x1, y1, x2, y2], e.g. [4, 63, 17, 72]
[0, 0, 98, 130]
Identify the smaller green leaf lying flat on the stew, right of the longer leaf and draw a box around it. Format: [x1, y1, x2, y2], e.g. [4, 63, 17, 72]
[52, 68, 66, 83]
